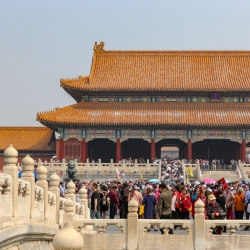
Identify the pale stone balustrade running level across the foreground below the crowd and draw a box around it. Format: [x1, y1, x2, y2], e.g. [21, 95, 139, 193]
[51, 199, 250, 250]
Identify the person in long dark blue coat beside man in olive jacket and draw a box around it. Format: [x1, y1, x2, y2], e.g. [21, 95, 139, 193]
[142, 186, 158, 231]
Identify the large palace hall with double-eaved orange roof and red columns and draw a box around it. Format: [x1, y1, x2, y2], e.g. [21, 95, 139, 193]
[37, 42, 250, 163]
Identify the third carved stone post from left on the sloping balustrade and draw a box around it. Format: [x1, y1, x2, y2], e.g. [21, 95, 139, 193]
[36, 161, 49, 220]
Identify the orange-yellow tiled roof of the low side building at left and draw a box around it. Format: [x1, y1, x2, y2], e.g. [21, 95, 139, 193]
[0, 127, 55, 151]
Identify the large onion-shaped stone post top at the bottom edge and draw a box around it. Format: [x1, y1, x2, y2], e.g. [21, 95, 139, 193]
[53, 221, 84, 250]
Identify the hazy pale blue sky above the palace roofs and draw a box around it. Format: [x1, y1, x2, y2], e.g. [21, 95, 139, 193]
[0, 0, 250, 126]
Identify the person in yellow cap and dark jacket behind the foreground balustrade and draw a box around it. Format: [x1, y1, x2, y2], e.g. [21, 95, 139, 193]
[206, 194, 226, 234]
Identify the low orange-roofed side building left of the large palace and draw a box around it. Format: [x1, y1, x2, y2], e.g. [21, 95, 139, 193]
[0, 127, 56, 170]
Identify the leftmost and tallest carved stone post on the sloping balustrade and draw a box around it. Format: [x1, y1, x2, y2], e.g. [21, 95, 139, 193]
[3, 144, 19, 217]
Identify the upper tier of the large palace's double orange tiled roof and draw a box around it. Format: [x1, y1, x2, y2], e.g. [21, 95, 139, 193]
[61, 47, 250, 92]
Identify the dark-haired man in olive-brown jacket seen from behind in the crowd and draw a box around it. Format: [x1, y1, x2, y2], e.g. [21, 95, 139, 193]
[158, 183, 174, 234]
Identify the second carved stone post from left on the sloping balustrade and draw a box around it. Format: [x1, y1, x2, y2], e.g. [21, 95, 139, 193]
[22, 155, 36, 219]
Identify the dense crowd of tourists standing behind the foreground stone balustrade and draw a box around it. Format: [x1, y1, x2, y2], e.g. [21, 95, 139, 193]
[60, 178, 250, 234]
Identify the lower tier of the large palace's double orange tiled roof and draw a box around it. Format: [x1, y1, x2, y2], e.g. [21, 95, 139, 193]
[37, 102, 250, 127]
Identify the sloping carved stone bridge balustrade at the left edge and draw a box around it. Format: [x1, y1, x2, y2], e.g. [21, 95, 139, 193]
[0, 145, 85, 249]
